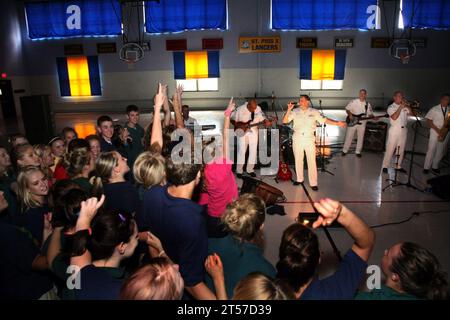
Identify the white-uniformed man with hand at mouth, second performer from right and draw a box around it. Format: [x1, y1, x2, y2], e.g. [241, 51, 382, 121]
[383, 91, 413, 173]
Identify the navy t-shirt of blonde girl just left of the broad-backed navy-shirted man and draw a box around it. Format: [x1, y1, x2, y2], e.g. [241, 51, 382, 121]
[103, 181, 142, 214]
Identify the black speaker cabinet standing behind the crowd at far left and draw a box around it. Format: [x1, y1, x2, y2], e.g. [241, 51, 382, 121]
[20, 95, 55, 144]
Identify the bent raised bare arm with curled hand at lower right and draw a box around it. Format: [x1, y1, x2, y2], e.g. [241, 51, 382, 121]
[313, 199, 375, 261]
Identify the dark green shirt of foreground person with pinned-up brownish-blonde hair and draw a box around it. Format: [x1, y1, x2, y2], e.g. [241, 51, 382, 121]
[206, 235, 276, 299]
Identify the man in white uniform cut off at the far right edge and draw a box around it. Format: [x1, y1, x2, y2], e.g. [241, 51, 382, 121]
[423, 93, 450, 174]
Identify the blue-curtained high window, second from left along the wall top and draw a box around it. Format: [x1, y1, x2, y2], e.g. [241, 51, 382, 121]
[145, 0, 227, 33]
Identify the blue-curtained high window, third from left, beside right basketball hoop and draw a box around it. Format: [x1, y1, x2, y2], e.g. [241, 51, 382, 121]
[272, 0, 377, 30]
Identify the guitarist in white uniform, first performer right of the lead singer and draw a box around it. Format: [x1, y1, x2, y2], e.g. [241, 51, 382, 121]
[342, 89, 373, 158]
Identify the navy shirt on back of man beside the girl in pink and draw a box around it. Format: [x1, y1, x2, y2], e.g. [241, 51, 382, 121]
[142, 186, 208, 287]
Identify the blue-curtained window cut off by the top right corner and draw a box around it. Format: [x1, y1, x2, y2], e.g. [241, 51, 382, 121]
[401, 0, 450, 30]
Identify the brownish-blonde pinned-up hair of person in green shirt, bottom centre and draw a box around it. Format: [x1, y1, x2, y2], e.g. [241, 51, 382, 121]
[222, 193, 266, 241]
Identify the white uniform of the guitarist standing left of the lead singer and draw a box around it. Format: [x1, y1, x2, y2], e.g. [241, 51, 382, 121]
[231, 102, 266, 173]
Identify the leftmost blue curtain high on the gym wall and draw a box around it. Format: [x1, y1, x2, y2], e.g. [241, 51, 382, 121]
[25, 0, 122, 39]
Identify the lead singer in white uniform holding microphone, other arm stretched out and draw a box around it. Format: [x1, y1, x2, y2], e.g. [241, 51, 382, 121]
[283, 95, 346, 191]
